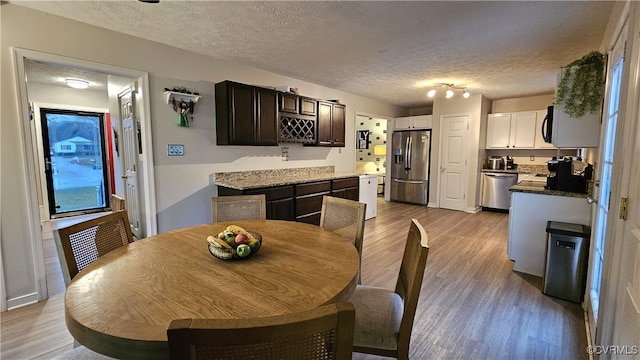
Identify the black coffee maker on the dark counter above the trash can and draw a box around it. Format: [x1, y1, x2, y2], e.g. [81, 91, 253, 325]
[546, 157, 593, 194]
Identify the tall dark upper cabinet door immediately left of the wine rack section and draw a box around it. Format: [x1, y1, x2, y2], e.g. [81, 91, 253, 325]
[255, 88, 278, 146]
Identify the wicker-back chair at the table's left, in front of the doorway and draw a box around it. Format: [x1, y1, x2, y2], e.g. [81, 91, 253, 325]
[53, 210, 133, 285]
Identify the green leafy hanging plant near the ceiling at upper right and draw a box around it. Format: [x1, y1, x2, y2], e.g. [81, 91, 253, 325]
[555, 51, 605, 118]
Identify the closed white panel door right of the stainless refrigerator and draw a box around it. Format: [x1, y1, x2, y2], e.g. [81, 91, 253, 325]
[439, 115, 469, 211]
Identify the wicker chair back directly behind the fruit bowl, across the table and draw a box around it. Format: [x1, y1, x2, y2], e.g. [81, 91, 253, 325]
[211, 194, 267, 223]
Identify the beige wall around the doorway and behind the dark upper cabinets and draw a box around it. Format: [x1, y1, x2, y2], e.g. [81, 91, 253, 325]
[0, 3, 407, 303]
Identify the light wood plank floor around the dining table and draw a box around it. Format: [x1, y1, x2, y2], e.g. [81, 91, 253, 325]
[0, 198, 588, 360]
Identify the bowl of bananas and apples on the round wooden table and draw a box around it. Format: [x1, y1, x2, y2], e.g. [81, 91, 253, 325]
[207, 225, 262, 260]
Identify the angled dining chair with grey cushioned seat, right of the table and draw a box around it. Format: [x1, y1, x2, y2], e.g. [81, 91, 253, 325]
[349, 219, 429, 359]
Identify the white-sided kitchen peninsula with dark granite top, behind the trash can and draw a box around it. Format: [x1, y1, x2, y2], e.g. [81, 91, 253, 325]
[507, 181, 591, 277]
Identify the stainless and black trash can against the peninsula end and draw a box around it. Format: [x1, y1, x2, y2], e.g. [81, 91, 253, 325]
[542, 221, 591, 303]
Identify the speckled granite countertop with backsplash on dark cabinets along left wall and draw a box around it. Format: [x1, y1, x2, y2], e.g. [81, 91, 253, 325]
[213, 166, 358, 190]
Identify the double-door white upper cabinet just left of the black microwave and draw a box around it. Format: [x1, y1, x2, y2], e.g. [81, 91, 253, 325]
[486, 111, 542, 149]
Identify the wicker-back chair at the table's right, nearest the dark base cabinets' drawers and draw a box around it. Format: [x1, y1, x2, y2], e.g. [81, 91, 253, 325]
[320, 195, 367, 284]
